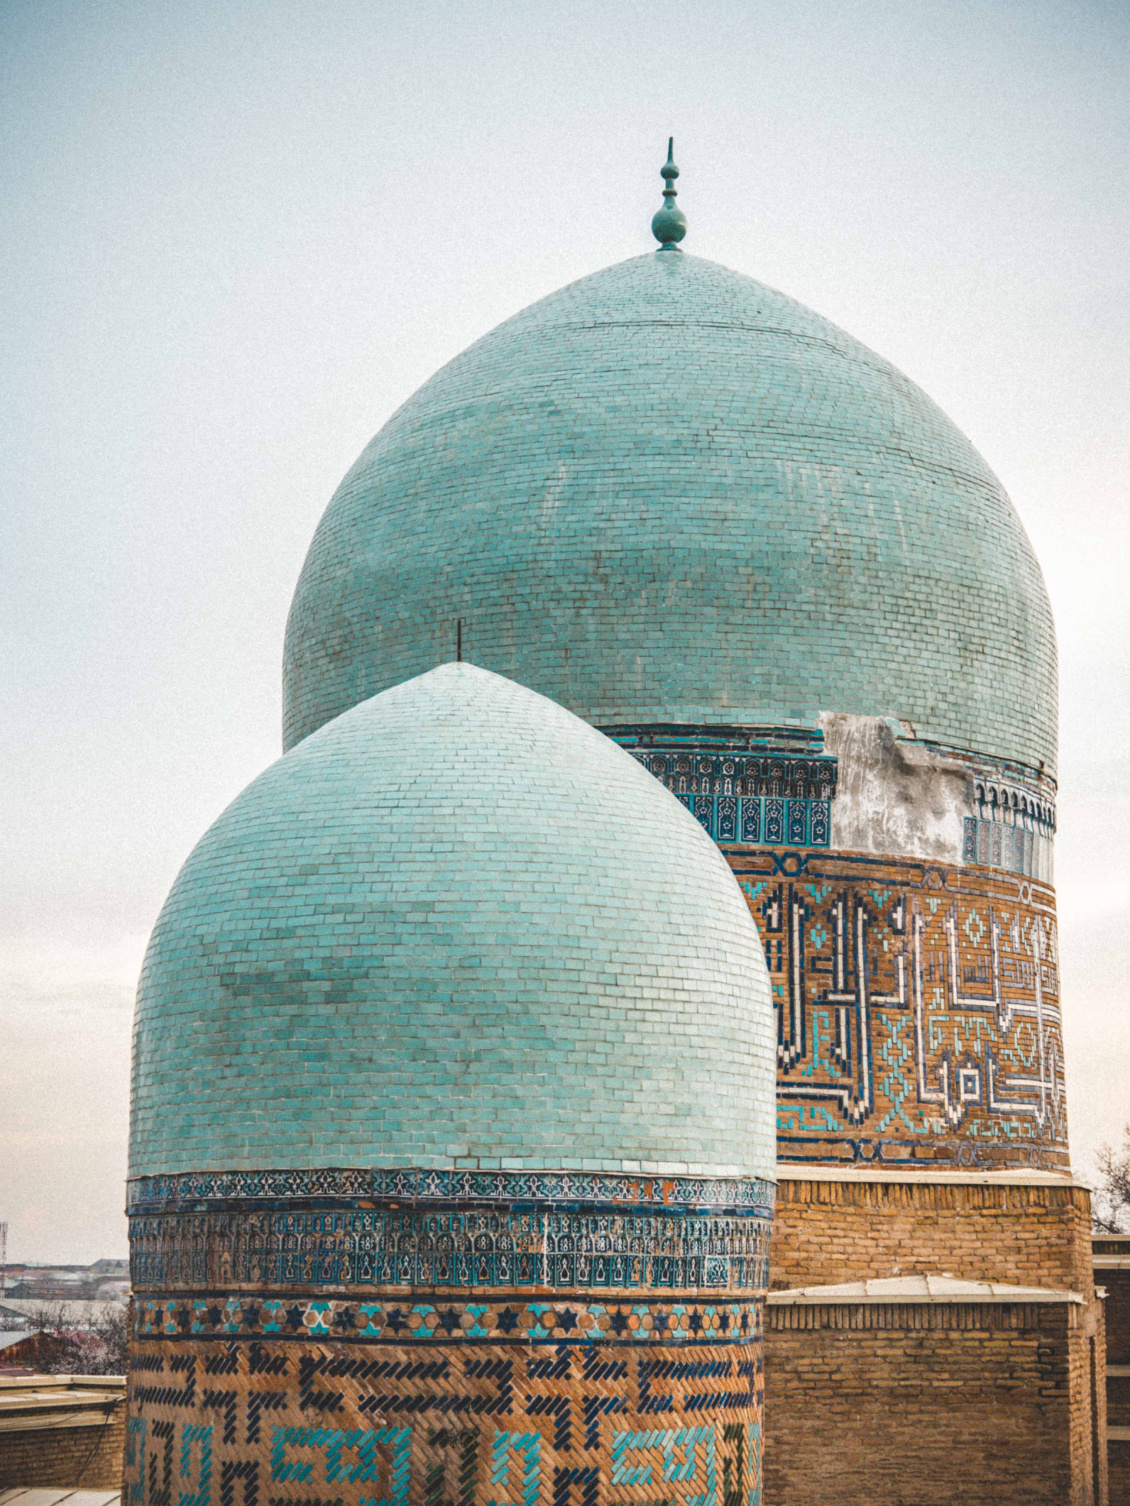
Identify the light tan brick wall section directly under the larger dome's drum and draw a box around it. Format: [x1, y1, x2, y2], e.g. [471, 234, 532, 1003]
[770, 1179, 1094, 1297]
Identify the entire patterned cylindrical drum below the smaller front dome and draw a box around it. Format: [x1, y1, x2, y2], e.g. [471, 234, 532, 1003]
[125, 1173, 771, 1506]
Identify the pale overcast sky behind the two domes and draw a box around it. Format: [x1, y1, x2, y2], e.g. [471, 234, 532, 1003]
[0, 0, 1130, 1261]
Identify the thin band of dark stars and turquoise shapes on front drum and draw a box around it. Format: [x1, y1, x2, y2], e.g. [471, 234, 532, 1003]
[131, 1291, 761, 1346]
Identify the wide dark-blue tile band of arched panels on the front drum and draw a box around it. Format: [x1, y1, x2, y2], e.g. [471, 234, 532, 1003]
[130, 1205, 770, 1291]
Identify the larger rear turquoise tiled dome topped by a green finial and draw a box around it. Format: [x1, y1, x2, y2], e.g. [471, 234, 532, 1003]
[285, 253, 1056, 773]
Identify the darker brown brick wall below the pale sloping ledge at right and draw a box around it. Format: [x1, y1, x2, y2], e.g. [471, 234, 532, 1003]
[764, 1304, 1103, 1506]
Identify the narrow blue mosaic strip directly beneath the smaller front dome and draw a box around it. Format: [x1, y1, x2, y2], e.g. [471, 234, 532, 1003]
[128, 1167, 773, 1217]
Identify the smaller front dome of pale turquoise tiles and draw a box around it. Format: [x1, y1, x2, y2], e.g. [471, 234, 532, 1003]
[130, 664, 774, 1176]
